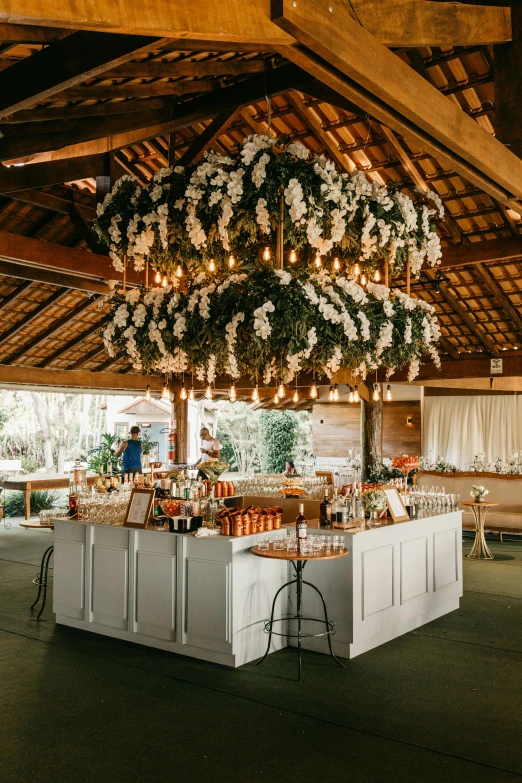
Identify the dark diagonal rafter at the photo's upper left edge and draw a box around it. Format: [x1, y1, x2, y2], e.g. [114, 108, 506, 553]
[0, 31, 167, 117]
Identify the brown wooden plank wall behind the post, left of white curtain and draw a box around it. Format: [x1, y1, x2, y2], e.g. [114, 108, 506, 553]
[312, 400, 421, 457]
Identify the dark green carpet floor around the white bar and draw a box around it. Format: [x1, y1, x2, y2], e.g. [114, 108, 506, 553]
[0, 525, 522, 783]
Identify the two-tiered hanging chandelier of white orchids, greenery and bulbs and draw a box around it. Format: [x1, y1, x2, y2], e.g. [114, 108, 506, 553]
[95, 136, 442, 392]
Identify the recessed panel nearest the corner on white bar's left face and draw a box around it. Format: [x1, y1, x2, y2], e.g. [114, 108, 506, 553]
[185, 557, 231, 651]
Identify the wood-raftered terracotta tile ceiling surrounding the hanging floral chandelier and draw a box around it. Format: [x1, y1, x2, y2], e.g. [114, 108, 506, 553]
[0, 0, 522, 392]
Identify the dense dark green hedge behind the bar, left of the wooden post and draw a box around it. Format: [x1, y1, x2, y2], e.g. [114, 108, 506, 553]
[259, 411, 298, 473]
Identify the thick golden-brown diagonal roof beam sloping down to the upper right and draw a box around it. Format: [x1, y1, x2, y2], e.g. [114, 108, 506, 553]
[272, 0, 522, 209]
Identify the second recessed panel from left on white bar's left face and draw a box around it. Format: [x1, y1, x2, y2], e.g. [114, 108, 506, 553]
[91, 544, 129, 629]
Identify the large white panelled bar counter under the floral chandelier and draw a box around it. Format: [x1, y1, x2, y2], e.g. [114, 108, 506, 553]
[53, 512, 462, 667]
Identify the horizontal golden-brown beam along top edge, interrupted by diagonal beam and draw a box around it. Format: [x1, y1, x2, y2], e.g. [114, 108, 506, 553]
[0, 0, 511, 51]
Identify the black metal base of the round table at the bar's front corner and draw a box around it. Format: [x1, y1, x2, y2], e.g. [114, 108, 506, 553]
[255, 560, 345, 682]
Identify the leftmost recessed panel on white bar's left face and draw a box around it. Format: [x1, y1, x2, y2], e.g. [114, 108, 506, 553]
[53, 540, 85, 620]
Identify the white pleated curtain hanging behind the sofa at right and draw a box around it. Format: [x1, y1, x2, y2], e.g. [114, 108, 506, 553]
[422, 395, 522, 470]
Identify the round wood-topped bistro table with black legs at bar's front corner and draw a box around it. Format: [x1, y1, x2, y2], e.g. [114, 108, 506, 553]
[250, 544, 348, 682]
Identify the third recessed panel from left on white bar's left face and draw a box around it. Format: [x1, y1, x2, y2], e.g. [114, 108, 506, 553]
[135, 551, 176, 639]
